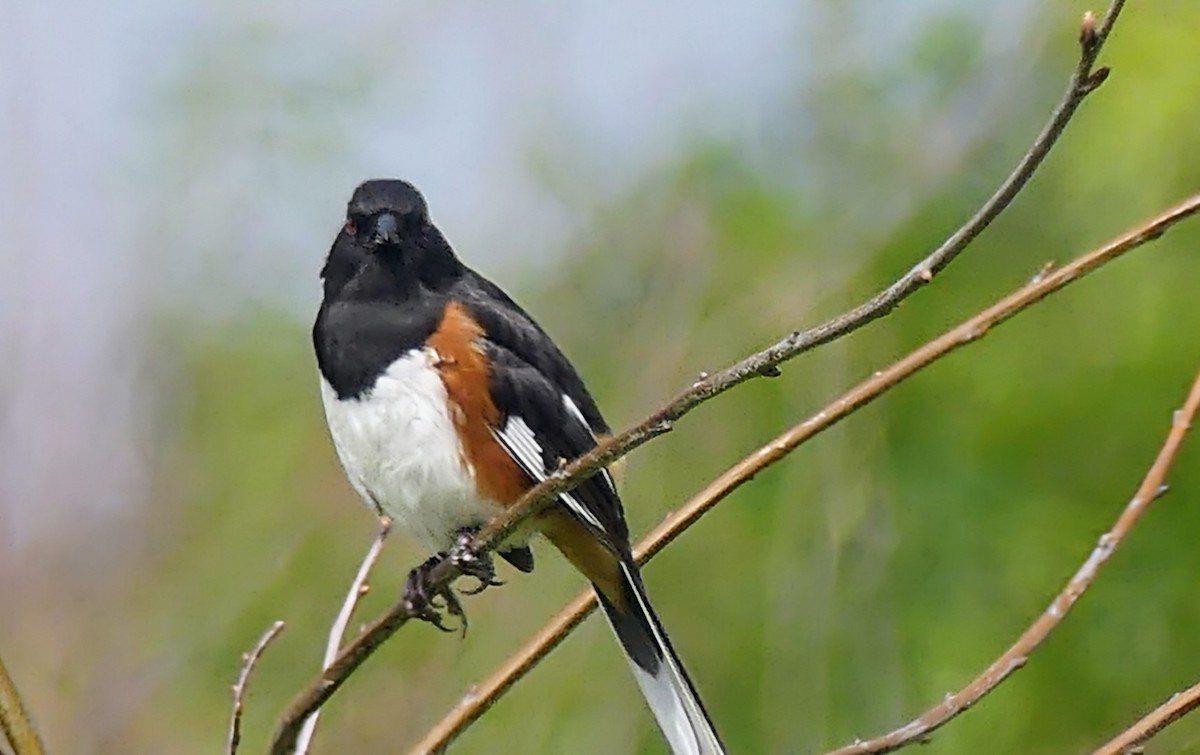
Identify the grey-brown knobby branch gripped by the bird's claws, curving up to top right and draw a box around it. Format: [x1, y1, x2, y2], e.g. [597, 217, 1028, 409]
[271, 10, 1124, 755]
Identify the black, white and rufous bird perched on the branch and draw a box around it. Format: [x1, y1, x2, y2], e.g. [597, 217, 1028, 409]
[312, 180, 724, 755]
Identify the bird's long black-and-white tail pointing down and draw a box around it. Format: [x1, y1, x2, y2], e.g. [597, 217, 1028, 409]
[596, 563, 725, 755]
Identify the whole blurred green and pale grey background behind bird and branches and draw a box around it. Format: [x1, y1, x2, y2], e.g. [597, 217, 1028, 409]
[0, 0, 1200, 754]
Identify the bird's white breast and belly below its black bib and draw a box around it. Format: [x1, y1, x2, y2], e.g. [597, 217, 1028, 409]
[320, 348, 498, 551]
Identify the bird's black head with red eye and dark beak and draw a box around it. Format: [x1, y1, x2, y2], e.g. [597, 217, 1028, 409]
[322, 179, 462, 298]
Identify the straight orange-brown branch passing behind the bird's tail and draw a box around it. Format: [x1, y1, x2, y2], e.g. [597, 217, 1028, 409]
[413, 194, 1200, 753]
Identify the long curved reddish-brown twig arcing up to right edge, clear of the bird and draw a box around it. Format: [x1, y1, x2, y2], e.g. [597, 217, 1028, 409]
[832, 367, 1200, 755]
